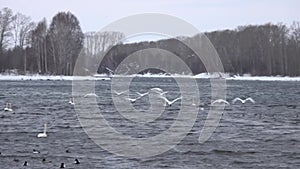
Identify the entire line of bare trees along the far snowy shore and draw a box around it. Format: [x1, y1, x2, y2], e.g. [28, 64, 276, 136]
[0, 8, 300, 76]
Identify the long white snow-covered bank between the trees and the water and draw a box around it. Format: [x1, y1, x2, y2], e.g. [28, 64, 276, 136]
[0, 73, 300, 81]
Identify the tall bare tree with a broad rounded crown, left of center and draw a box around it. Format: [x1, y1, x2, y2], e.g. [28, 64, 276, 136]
[48, 12, 84, 75]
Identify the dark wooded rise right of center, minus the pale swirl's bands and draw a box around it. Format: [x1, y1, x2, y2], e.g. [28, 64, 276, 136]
[99, 22, 300, 76]
